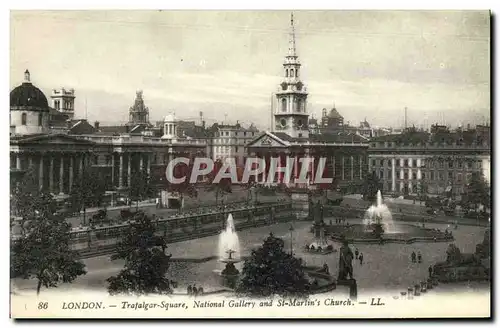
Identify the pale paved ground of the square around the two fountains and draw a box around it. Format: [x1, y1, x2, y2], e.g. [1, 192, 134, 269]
[13, 218, 485, 295]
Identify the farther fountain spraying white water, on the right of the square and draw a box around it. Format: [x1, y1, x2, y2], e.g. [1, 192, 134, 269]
[363, 190, 397, 238]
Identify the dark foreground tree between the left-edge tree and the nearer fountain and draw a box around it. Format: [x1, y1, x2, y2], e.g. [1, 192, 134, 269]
[107, 212, 172, 295]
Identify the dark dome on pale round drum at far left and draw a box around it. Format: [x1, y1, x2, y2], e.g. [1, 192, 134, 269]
[10, 70, 49, 135]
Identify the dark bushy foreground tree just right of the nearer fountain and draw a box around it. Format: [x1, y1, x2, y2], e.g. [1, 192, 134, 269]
[237, 233, 310, 297]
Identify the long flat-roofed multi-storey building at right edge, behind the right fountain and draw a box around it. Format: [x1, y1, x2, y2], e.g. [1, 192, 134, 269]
[369, 124, 491, 195]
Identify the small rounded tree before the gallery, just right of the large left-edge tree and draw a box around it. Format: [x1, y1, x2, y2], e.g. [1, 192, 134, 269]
[69, 167, 106, 224]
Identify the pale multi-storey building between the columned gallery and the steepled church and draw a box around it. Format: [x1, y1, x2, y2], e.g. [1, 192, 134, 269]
[209, 123, 259, 166]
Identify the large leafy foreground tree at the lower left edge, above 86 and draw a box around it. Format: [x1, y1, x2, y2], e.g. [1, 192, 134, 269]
[11, 193, 86, 294]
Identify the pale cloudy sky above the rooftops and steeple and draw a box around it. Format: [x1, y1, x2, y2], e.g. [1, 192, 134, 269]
[10, 11, 491, 129]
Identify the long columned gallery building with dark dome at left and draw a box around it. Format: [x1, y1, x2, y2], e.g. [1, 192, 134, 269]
[10, 71, 207, 208]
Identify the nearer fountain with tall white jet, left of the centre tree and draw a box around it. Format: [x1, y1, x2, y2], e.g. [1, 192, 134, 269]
[219, 214, 241, 288]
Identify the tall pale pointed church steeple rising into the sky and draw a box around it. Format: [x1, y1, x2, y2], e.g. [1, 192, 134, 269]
[274, 14, 309, 138]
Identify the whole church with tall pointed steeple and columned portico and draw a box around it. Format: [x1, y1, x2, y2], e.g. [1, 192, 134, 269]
[247, 16, 368, 189]
